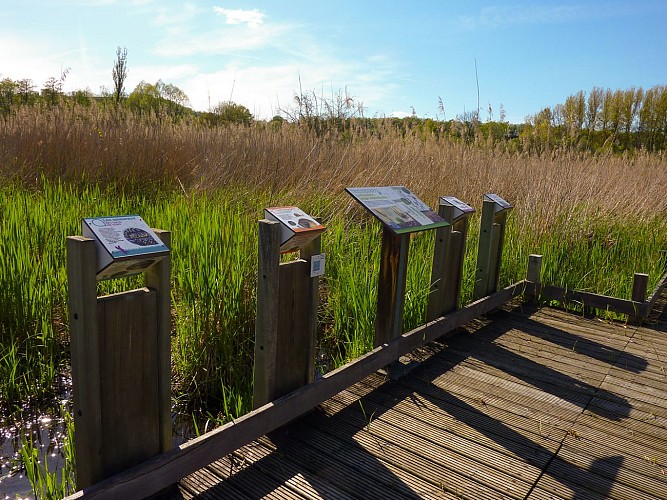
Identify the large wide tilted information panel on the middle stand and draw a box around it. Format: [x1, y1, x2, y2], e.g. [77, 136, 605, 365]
[345, 186, 448, 234]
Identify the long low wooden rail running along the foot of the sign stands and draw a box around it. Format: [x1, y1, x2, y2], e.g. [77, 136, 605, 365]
[67, 281, 526, 499]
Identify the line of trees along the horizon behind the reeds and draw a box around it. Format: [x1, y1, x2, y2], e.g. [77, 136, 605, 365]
[0, 47, 667, 154]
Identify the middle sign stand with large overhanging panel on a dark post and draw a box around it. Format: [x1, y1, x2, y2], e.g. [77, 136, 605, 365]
[346, 186, 448, 354]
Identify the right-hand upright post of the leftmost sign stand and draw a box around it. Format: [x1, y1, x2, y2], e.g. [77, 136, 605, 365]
[144, 229, 172, 453]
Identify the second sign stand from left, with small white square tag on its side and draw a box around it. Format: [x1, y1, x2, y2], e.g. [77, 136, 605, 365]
[253, 207, 325, 408]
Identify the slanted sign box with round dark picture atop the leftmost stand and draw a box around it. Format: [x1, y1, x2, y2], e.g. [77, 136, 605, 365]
[81, 215, 169, 280]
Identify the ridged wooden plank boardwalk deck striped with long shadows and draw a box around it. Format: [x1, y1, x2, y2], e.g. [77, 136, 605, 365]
[162, 306, 667, 500]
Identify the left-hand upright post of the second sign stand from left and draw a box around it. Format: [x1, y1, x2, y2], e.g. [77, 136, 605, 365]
[253, 219, 280, 408]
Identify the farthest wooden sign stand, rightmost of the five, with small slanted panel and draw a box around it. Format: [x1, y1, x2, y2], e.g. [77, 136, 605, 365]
[473, 194, 512, 300]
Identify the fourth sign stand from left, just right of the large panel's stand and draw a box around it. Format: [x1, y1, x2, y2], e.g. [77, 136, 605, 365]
[426, 196, 475, 321]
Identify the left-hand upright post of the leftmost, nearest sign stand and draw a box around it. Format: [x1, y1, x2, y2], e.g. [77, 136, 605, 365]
[67, 236, 102, 489]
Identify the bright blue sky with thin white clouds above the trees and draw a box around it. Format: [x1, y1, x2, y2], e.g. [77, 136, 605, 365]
[0, 0, 667, 123]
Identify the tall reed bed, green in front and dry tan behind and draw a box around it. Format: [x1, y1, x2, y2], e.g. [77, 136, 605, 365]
[0, 107, 667, 496]
